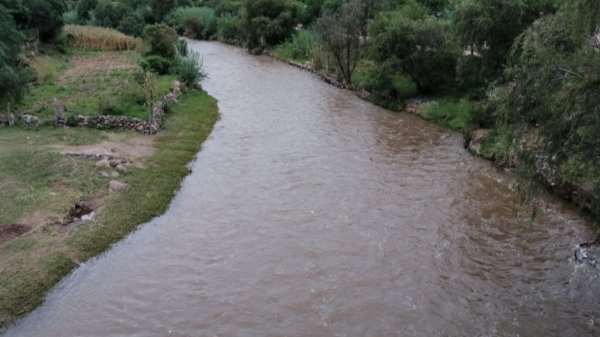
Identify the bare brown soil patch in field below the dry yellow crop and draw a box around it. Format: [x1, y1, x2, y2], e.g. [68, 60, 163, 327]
[59, 54, 137, 82]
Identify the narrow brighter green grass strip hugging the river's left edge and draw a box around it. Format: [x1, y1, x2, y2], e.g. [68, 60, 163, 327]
[71, 93, 217, 258]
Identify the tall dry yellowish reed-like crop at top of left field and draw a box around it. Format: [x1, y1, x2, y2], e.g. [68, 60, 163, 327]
[63, 25, 143, 51]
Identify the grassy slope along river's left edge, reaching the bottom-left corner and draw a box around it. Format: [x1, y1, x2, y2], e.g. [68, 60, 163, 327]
[0, 91, 218, 326]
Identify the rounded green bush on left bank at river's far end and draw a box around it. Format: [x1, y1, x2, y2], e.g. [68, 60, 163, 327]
[166, 7, 217, 39]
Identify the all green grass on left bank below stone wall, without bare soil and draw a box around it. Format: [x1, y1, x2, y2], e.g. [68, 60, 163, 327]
[0, 88, 218, 326]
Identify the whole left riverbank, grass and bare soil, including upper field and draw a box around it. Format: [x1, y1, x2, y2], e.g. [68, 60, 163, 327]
[0, 43, 218, 327]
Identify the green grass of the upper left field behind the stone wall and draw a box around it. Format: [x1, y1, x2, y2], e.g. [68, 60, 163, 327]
[16, 49, 152, 121]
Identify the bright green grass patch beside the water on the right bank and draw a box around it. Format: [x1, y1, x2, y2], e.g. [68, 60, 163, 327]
[418, 98, 478, 133]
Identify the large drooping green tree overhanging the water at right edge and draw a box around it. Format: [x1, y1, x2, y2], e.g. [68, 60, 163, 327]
[489, 0, 600, 216]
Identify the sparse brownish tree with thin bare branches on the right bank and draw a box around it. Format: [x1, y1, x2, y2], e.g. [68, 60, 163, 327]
[316, 1, 364, 86]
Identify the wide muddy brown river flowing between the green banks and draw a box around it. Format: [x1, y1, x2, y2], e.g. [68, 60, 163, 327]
[4, 42, 600, 337]
